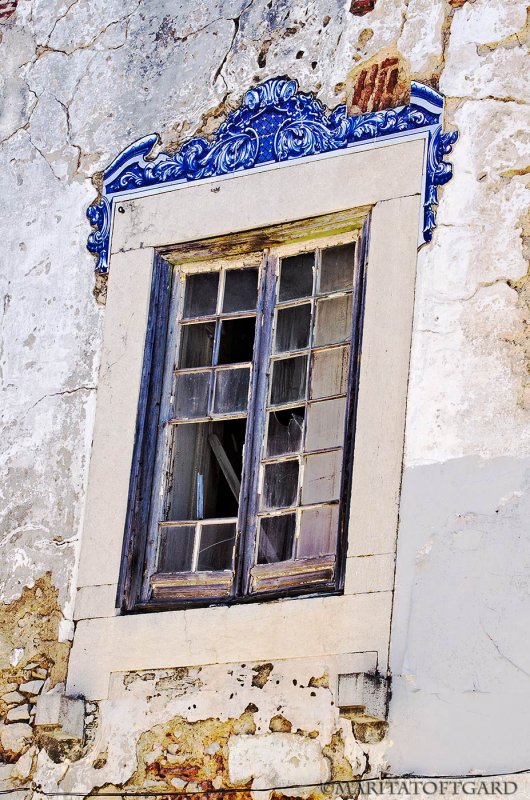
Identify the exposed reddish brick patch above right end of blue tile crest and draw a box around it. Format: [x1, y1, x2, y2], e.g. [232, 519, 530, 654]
[346, 51, 410, 114]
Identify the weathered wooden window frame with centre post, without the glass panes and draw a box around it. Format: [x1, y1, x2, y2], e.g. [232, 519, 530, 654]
[116, 214, 370, 614]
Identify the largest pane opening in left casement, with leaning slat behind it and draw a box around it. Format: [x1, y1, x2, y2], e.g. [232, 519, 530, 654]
[166, 419, 246, 521]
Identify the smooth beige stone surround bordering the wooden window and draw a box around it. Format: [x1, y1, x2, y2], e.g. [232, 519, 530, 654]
[71, 136, 425, 699]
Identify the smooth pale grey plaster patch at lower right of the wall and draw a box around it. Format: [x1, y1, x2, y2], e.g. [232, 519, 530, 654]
[388, 457, 530, 775]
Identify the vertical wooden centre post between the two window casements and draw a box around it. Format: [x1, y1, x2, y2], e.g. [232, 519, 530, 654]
[236, 250, 279, 594]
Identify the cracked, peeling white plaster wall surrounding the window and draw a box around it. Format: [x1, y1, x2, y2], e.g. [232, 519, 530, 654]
[0, 0, 530, 789]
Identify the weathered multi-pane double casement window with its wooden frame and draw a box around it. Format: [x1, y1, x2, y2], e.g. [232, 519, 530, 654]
[119, 215, 364, 609]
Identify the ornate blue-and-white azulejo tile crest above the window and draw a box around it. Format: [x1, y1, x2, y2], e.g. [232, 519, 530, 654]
[87, 78, 458, 273]
